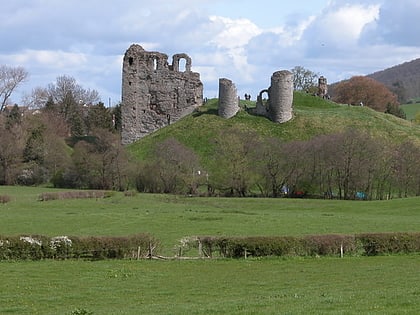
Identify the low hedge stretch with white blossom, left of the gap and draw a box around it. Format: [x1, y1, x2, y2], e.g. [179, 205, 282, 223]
[0, 234, 159, 260]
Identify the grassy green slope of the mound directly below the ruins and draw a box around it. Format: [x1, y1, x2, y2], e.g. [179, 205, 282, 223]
[128, 92, 420, 159]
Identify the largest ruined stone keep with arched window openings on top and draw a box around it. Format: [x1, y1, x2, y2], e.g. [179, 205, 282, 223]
[121, 44, 203, 144]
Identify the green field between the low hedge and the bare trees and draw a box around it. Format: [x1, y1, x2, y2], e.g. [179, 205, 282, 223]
[0, 187, 420, 255]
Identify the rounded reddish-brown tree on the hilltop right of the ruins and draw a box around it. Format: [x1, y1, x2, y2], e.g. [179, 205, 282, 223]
[333, 76, 399, 112]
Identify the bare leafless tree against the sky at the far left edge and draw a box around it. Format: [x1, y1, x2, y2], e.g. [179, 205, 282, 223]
[0, 65, 28, 112]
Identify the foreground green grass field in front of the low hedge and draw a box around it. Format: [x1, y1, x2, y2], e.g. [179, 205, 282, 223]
[0, 255, 420, 315]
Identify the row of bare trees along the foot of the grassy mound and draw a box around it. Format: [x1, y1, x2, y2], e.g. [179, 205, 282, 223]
[136, 128, 420, 200]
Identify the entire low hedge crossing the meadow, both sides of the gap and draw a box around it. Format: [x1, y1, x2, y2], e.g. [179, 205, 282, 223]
[0, 232, 420, 260]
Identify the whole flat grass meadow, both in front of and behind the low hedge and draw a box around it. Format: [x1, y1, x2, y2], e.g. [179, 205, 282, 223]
[0, 187, 420, 314]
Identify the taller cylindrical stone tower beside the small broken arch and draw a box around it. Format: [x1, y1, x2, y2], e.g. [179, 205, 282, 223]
[268, 70, 293, 123]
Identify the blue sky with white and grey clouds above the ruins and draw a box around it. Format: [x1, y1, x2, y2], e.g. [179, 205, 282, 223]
[0, 0, 420, 106]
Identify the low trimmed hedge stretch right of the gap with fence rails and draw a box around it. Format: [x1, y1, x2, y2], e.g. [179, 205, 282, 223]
[189, 232, 420, 258]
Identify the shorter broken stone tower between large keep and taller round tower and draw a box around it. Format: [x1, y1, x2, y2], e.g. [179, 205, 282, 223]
[218, 78, 239, 118]
